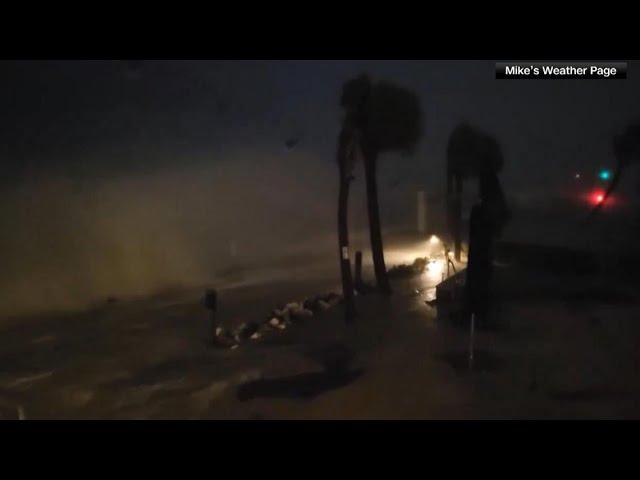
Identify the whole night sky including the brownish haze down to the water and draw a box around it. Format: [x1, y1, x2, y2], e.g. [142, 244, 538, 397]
[0, 60, 640, 316]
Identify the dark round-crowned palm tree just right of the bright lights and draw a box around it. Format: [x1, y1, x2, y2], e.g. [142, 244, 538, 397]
[447, 123, 509, 261]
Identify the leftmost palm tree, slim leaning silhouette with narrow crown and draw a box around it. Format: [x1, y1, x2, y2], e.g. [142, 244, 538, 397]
[337, 75, 371, 322]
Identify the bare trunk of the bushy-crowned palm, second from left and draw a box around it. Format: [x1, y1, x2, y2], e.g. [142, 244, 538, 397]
[363, 149, 391, 294]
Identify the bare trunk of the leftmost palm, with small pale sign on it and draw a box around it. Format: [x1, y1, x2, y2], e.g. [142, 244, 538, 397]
[338, 166, 356, 322]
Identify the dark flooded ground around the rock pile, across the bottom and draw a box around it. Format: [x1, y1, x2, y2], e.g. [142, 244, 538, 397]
[0, 242, 640, 419]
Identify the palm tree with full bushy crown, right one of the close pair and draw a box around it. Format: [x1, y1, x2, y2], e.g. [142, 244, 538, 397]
[362, 82, 422, 293]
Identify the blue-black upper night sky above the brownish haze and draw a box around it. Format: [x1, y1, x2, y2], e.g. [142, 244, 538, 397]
[5, 61, 640, 199]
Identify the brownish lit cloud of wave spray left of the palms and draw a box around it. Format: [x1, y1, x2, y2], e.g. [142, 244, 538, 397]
[0, 150, 350, 316]
